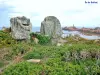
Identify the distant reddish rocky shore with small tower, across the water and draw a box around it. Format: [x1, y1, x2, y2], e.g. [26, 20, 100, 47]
[62, 25, 100, 34]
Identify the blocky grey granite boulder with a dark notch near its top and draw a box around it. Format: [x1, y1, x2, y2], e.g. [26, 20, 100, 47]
[10, 16, 32, 40]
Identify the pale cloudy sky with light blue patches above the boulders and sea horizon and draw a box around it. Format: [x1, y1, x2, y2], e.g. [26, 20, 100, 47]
[0, 0, 100, 27]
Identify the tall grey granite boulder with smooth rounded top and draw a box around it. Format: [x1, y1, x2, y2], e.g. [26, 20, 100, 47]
[40, 16, 62, 44]
